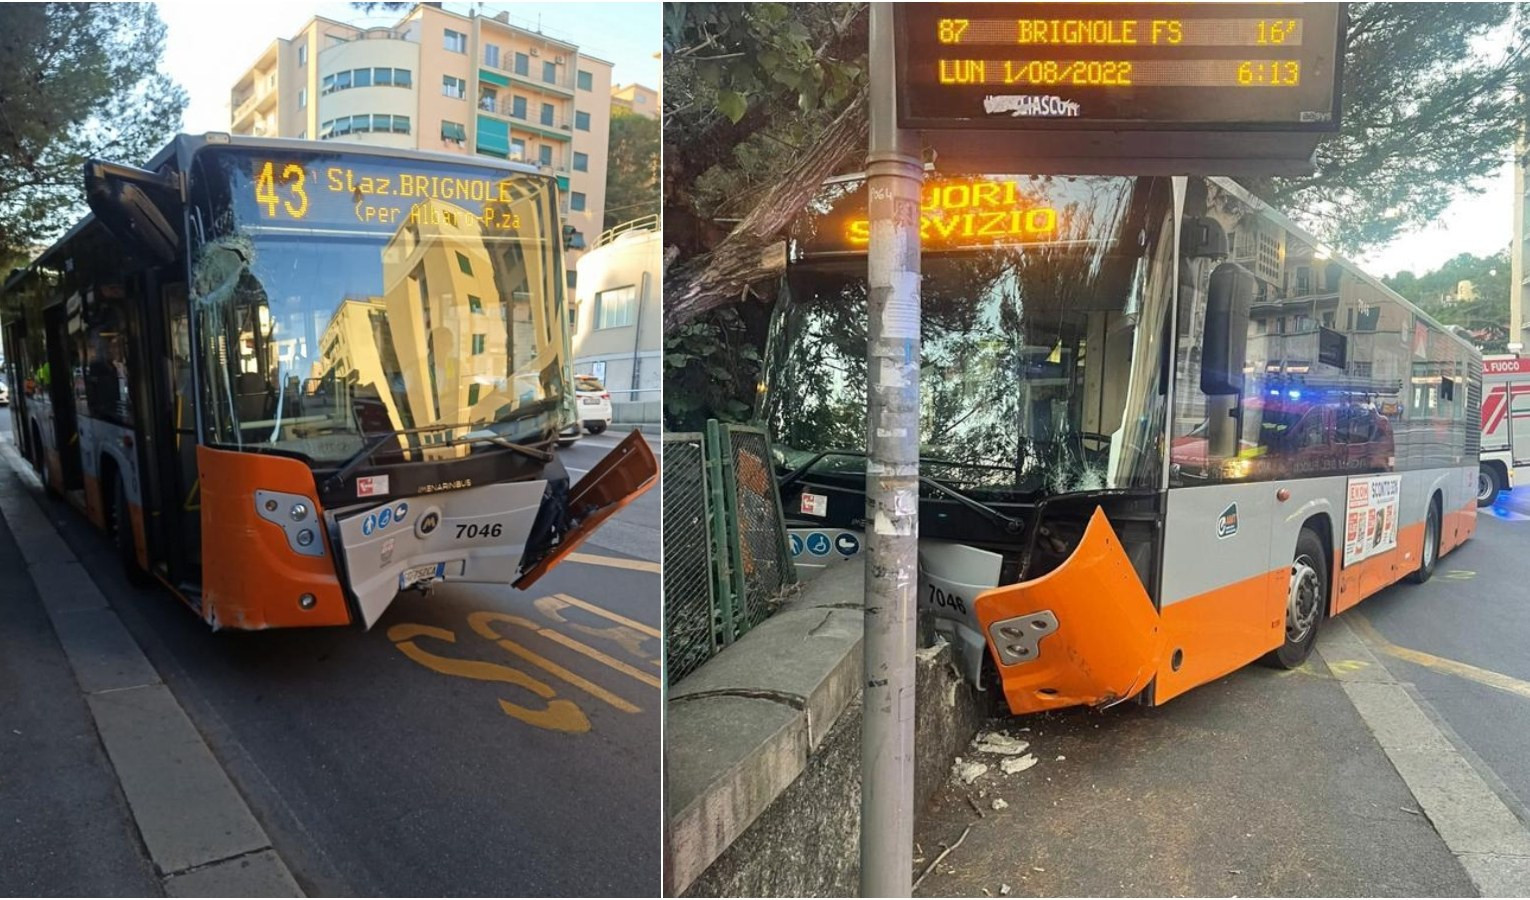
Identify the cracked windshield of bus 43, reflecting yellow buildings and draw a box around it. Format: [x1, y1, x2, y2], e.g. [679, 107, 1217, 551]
[181, 148, 569, 465]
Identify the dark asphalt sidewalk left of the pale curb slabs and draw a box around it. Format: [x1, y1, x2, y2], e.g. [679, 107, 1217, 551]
[0, 477, 164, 897]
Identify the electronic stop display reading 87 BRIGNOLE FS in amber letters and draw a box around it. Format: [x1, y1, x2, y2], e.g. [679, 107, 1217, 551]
[897, 3, 1342, 132]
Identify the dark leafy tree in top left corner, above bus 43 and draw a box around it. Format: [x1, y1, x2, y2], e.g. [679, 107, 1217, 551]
[0, 3, 187, 256]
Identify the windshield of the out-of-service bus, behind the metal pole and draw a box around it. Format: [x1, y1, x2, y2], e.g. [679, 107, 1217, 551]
[765, 176, 1174, 502]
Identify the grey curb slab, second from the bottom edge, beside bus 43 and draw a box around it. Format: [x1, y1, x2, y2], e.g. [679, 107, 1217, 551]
[87, 684, 269, 872]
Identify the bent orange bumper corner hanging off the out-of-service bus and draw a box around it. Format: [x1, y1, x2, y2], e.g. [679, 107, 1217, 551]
[973, 510, 1164, 715]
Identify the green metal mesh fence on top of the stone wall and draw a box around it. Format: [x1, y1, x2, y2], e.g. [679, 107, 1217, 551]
[662, 419, 797, 684]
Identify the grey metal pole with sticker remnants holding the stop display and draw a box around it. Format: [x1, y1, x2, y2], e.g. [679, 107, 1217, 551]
[860, 3, 924, 897]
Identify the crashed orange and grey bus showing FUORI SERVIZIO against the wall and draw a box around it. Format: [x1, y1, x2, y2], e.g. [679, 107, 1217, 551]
[762, 173, 1483, 713]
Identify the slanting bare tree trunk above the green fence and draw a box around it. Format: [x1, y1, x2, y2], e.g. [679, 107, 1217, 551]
[664, 92, 868, 334]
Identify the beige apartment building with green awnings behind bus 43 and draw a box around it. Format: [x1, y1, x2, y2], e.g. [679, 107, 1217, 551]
[230, 3, 612, 270]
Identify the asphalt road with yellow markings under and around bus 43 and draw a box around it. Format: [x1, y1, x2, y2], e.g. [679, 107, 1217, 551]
[0, 412, 661, 897]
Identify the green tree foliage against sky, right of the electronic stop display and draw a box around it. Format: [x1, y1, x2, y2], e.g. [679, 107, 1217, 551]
[1252, 3, 1530, 253]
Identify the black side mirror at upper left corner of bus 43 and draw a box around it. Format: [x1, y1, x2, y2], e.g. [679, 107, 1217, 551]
[84, 159, 181, 263]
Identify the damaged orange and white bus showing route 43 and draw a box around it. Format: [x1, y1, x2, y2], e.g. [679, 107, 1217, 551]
[0, 135, 656, 629]
